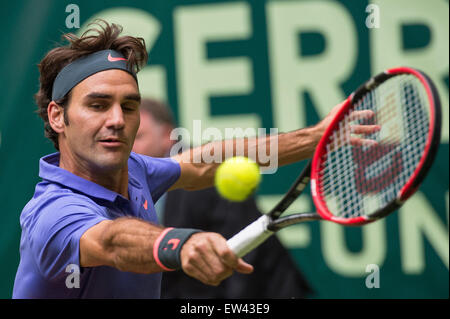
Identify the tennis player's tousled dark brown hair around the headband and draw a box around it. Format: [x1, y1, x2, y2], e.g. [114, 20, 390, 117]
[34, 19, 148, 150]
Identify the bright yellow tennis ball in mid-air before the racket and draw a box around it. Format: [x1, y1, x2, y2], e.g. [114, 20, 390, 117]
[215, 156, 261, 202]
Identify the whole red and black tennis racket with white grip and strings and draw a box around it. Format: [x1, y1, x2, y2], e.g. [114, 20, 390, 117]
[228, 67, 441, 257]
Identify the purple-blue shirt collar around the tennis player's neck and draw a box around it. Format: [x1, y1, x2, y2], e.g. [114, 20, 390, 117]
[39, 152, 136, 202]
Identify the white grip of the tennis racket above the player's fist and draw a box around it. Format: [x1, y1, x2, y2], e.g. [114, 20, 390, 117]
[227, 215, 274, 257]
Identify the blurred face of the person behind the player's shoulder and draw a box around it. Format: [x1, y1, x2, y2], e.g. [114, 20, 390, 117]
[133, 110, 175, 157]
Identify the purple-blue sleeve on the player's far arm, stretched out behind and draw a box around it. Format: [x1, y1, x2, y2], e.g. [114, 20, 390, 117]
[132, 153, 181, 203]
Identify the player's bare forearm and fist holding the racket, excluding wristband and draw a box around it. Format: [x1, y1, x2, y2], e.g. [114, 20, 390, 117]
[80, 218, 253, 285]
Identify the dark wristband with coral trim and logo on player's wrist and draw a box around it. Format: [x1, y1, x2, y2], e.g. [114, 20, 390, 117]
[153, 228, 201, 271]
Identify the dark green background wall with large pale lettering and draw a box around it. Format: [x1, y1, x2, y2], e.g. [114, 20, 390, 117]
[0, 0, 449, 298]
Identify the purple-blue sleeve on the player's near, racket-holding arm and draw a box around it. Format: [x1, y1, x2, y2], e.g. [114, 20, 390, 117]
[28, 196, 107, 280]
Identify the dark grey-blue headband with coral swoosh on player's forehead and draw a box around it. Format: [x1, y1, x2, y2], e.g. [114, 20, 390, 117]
[52, 50, 137, 101]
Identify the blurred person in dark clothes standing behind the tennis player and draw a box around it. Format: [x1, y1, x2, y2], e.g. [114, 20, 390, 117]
[133, 99, 312, 298]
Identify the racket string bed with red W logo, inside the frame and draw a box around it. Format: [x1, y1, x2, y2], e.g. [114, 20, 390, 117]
[319, 75, 430, 218]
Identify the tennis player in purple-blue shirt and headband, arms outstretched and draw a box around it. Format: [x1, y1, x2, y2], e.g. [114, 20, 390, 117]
[13, 21, 374, 298]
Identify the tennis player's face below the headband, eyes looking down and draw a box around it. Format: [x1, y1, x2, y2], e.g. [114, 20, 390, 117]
[59, 70, 140, 174]
